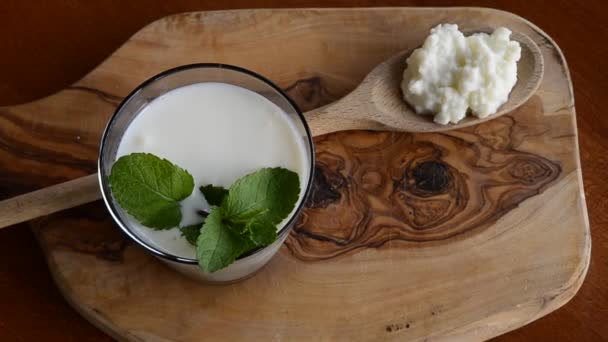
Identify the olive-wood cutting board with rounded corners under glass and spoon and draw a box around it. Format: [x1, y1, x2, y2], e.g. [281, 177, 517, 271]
[0, 8, 591, 341]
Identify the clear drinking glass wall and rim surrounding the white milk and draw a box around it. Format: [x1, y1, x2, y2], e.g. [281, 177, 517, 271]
[98, 63, 314, 283]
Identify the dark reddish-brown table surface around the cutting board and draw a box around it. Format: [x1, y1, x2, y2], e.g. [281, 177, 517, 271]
[0, 0, 608, 341]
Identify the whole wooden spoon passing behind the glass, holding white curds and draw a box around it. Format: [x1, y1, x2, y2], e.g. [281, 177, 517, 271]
[0, 32, 544, 228]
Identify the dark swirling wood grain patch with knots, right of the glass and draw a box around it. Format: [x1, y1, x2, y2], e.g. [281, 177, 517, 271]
[288, 100, 560, 261]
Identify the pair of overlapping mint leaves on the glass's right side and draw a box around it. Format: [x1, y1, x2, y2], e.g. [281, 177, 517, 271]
[196, 167, 300, 272]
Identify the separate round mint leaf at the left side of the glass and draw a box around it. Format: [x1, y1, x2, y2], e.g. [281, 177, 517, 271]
[109, 153, 194, 229]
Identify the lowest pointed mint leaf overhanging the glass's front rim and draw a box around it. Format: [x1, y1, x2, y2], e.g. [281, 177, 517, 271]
[196, 208, 251, 272]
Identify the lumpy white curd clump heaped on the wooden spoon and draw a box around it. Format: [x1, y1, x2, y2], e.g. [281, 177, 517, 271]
[401, 24, 521, 125]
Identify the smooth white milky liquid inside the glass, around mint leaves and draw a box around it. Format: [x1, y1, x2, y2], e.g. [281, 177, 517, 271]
[116, 82, 310, 258]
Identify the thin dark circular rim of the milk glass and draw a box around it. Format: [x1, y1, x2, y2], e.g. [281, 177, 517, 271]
[97, 63, 315, 265]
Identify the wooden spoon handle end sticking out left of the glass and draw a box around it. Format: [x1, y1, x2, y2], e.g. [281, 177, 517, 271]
[0, 174, 101, 229]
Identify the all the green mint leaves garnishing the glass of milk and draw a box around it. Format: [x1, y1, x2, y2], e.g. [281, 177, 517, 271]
[109, 153, 300, 272]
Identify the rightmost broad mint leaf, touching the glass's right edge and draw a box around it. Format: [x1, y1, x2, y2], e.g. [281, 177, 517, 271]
[222, 167, 300, 229]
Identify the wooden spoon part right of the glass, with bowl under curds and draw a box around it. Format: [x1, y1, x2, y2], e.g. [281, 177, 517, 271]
[305, 31, 544, 136]
